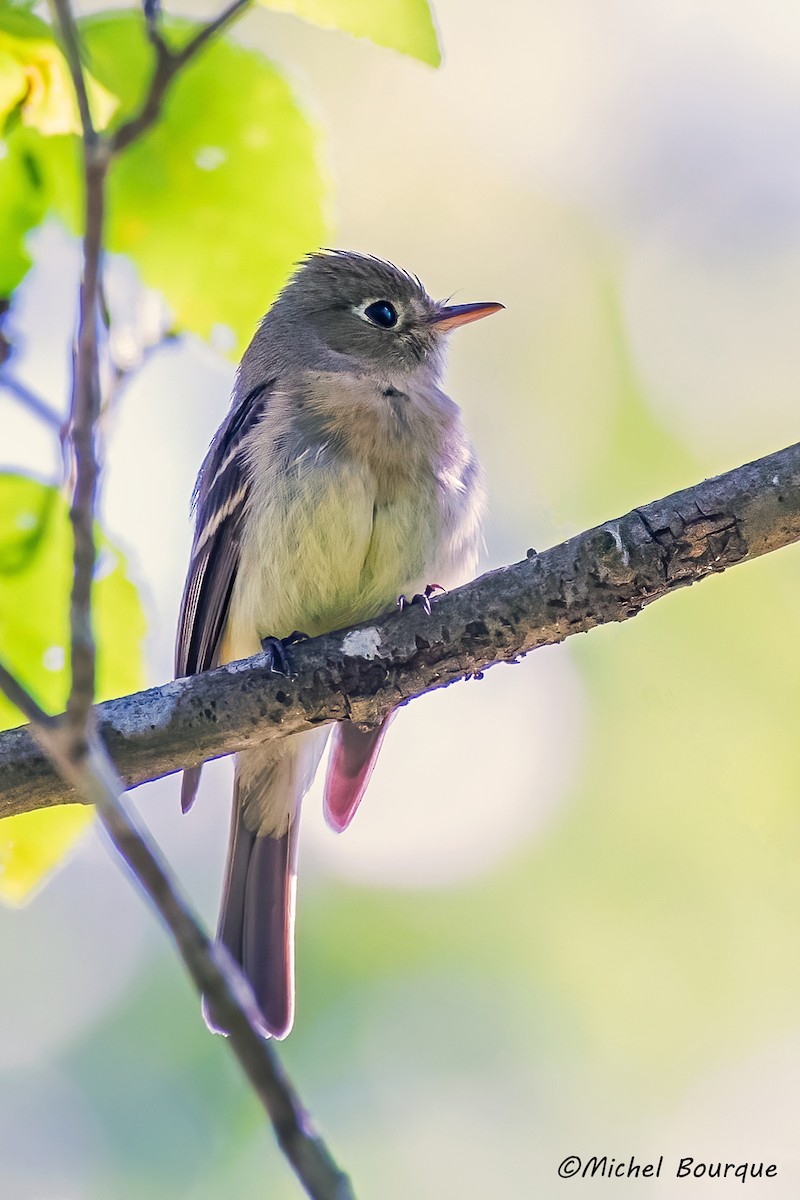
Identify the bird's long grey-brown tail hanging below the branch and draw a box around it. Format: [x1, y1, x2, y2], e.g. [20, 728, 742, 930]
[208, 730, 327, 1038]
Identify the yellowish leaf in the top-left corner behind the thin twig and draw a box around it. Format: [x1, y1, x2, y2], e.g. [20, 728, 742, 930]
[0, 4, 116, 136]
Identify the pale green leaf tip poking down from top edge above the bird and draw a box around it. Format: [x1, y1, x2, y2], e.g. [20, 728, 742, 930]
[260, 0, 441, 67]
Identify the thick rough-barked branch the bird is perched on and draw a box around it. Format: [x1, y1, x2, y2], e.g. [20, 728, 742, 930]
[0, 443, 800, 816]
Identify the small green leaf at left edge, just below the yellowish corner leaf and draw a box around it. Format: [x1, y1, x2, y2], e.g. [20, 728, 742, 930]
[0, 126, 79, 296]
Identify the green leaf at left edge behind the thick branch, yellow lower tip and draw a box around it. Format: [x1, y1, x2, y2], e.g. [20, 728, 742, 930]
[0, 474, 145, 904]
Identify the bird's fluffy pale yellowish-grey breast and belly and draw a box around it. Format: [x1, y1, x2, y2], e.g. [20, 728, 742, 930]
[221, 380, 479, 656]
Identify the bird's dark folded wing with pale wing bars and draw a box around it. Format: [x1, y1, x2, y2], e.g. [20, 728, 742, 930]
[175, 382, 273, 811]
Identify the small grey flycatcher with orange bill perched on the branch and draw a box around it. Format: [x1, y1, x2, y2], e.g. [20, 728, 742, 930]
[175, 250, 504, 1039]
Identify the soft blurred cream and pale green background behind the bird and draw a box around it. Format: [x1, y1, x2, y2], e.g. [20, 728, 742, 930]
[0, 0, 800, 1200]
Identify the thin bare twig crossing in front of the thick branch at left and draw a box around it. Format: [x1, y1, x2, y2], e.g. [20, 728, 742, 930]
[9, 0, 353, 1200]
